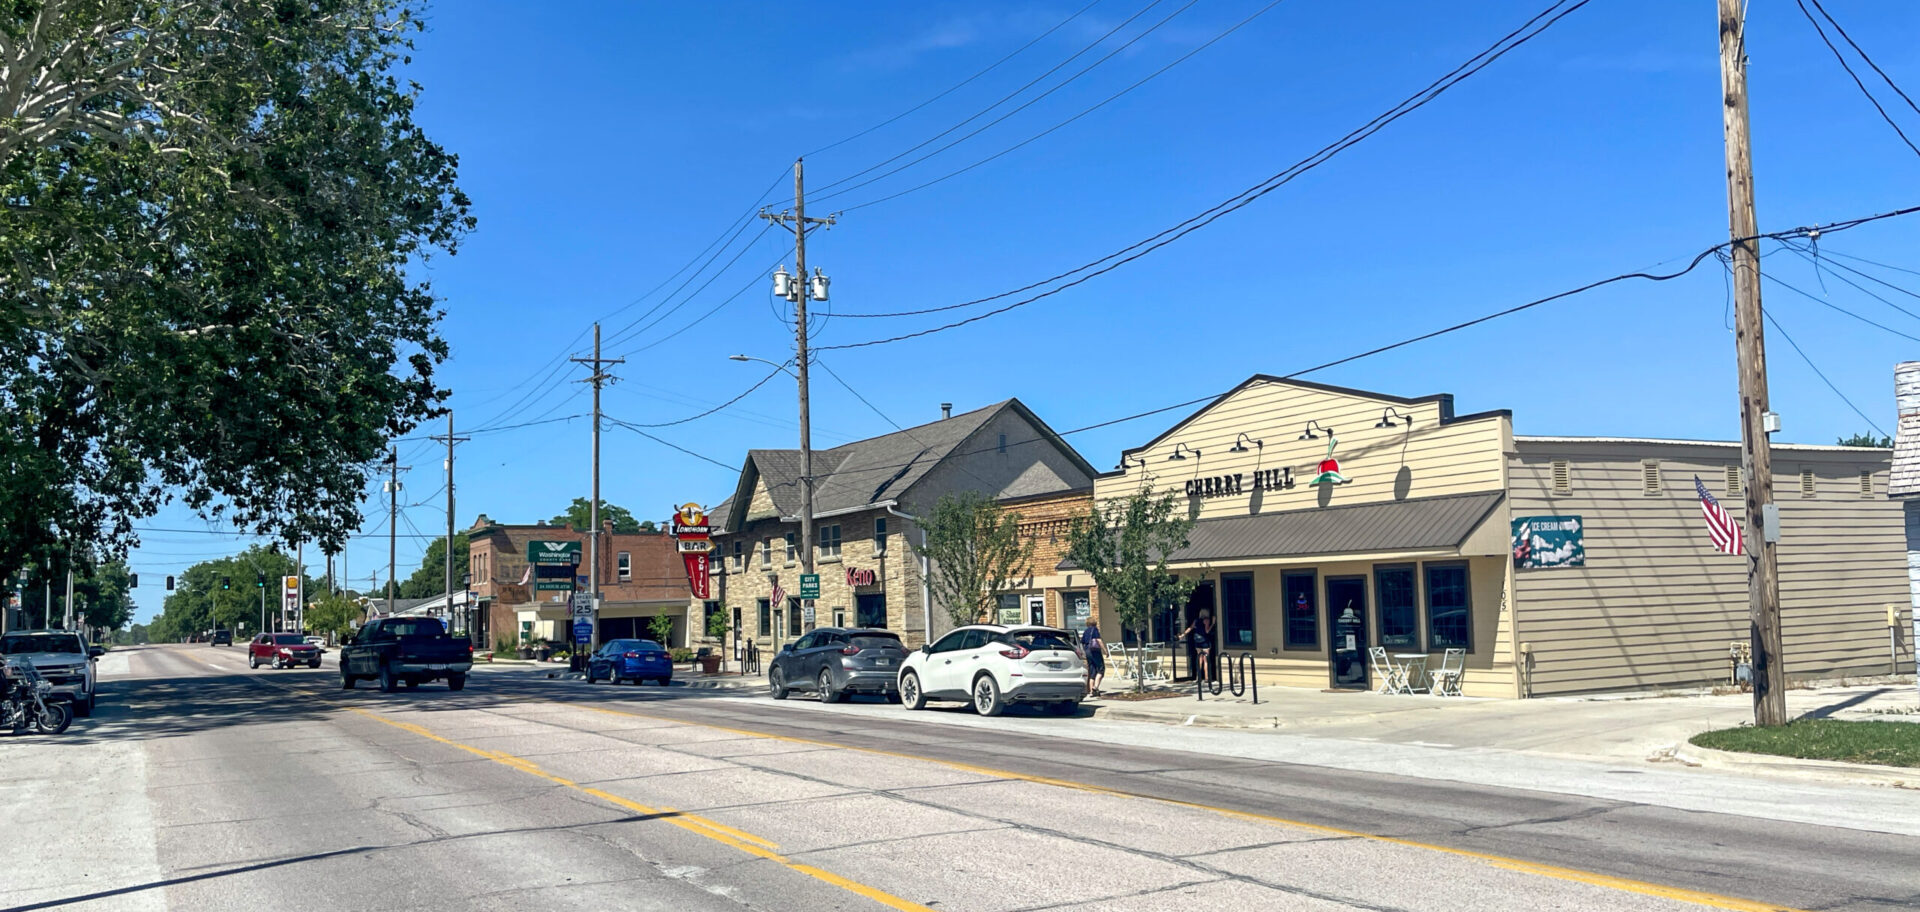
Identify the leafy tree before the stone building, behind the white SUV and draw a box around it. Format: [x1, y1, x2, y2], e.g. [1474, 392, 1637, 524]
[912, 492, 1033, 626]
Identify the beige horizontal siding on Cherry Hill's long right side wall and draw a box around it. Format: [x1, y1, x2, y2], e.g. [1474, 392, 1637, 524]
[1509, 438, 1907, 695]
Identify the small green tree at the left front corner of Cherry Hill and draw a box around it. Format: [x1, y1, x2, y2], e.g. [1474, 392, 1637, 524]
[1068, 490, 1194, 691]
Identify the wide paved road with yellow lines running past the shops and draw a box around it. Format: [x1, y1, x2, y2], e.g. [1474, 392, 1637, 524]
[0, 645, 1920, 912]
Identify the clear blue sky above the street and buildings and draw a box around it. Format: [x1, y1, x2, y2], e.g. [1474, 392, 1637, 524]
[116, 0, 1920, 620]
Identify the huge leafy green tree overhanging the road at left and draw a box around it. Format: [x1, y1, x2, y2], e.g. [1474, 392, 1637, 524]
[0, 0, 472, 572]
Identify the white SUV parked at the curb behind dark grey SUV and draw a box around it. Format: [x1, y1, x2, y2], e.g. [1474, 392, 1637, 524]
[900, 624, 1087, 716]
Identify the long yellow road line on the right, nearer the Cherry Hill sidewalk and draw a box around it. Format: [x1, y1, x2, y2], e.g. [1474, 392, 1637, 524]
[564, 701, 1807, 912]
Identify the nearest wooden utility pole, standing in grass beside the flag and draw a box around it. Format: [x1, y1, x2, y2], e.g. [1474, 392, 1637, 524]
[1718, 0, 1788, 726]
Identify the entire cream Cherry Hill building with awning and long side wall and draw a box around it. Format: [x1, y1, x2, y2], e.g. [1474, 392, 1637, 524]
[1062, 376, 1907, 697]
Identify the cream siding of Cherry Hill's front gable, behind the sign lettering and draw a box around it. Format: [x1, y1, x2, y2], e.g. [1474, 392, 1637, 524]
[1094, 382, 1509, 518]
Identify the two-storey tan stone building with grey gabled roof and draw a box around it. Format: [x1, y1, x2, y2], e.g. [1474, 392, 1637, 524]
[703, 399, 1094, 651]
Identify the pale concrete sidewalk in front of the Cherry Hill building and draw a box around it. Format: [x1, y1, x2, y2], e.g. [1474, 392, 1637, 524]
[1087, 680, 1920, 781]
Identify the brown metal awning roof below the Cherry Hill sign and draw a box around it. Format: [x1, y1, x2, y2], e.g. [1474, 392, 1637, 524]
[1060, 492, 1505, 570]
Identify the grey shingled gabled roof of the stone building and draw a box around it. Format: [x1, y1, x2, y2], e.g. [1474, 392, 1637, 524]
[714, 399, 1096, 530]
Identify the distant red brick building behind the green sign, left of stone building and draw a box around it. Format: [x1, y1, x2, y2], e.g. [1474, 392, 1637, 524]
[467, 513, 687, 647]
